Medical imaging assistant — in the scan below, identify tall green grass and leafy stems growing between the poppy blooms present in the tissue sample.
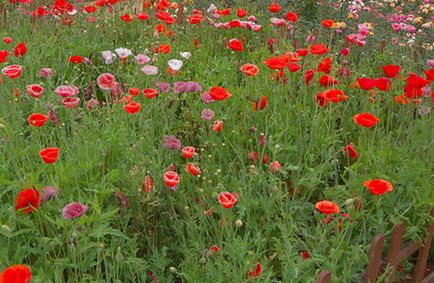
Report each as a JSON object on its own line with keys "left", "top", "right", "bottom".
{"left": 0, "top": 1, "right": 434, "bottom": 282}
